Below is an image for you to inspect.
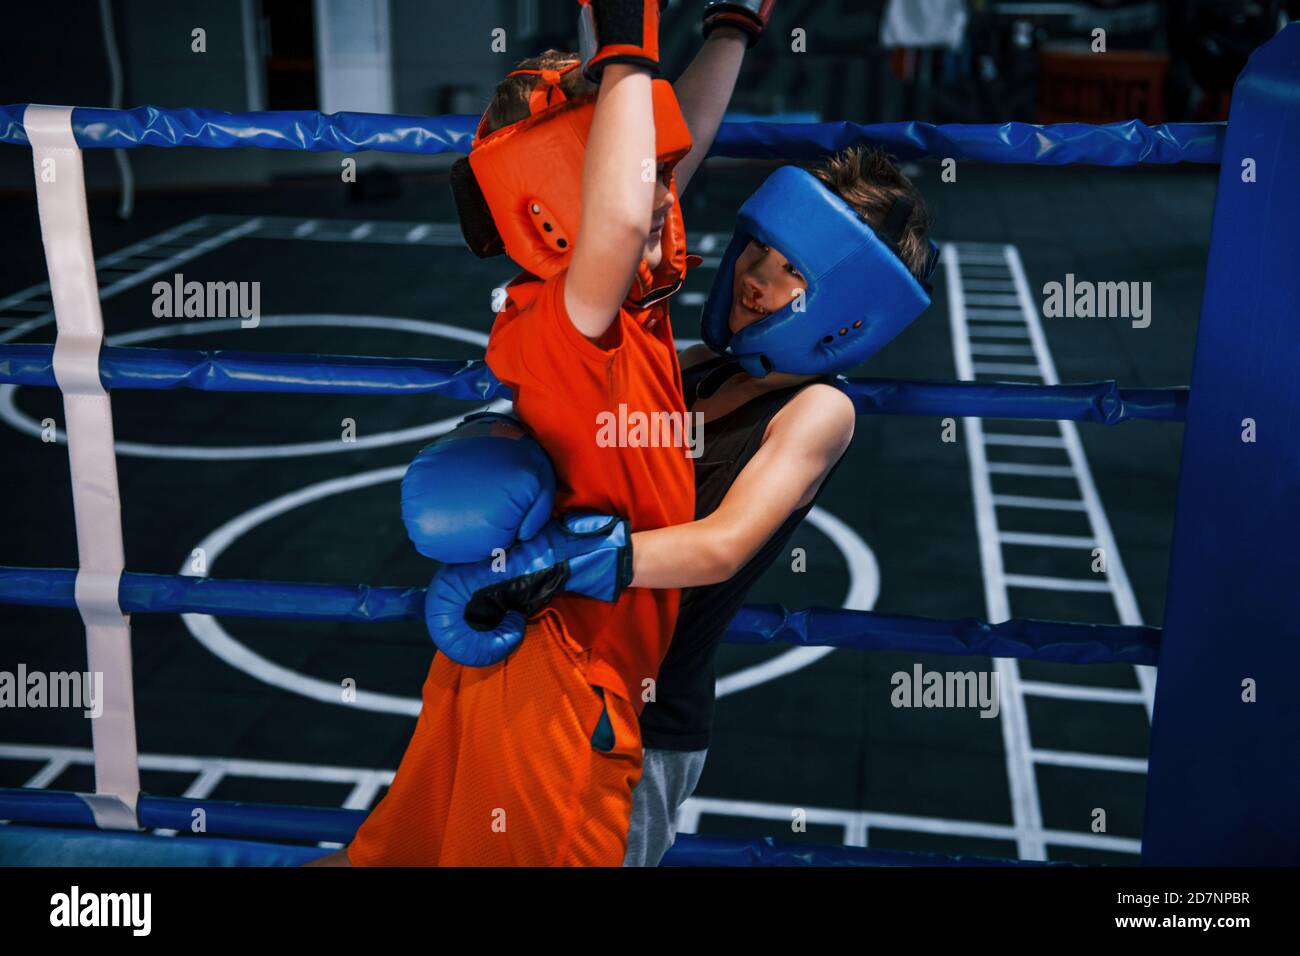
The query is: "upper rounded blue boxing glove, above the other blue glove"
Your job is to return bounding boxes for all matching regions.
[402,412,555,563]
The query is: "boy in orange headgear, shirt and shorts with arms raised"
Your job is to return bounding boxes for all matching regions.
[323,0,771,865]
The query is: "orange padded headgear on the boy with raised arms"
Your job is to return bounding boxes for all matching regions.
[451,60,690,278]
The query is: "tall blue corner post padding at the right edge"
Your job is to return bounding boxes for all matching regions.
[1143,23,1300,866]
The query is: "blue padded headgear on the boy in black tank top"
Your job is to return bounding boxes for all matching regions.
[701,166,939,378]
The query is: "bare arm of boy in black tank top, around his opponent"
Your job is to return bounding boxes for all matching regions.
[632,385,855,588]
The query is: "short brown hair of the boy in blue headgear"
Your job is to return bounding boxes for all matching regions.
[809,146,930,281]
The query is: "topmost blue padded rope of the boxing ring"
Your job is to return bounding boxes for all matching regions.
[0,103,1223,166]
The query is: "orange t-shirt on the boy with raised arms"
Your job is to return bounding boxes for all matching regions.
[488,267,696,713]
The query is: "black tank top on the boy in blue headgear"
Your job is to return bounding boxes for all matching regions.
[641,356,840,750]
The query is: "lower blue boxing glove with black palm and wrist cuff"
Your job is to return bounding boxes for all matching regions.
[424,514,632,667]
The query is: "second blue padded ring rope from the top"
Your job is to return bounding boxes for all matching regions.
[0,345,1187,425]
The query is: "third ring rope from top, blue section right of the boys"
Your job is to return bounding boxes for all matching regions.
[727,605,1160,663]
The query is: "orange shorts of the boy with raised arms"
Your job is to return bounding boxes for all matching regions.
[347,611,641,866]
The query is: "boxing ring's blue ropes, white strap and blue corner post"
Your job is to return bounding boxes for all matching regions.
[0,26,1300,866]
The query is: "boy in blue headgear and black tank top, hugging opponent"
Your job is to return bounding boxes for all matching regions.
[624,148,939,866]
